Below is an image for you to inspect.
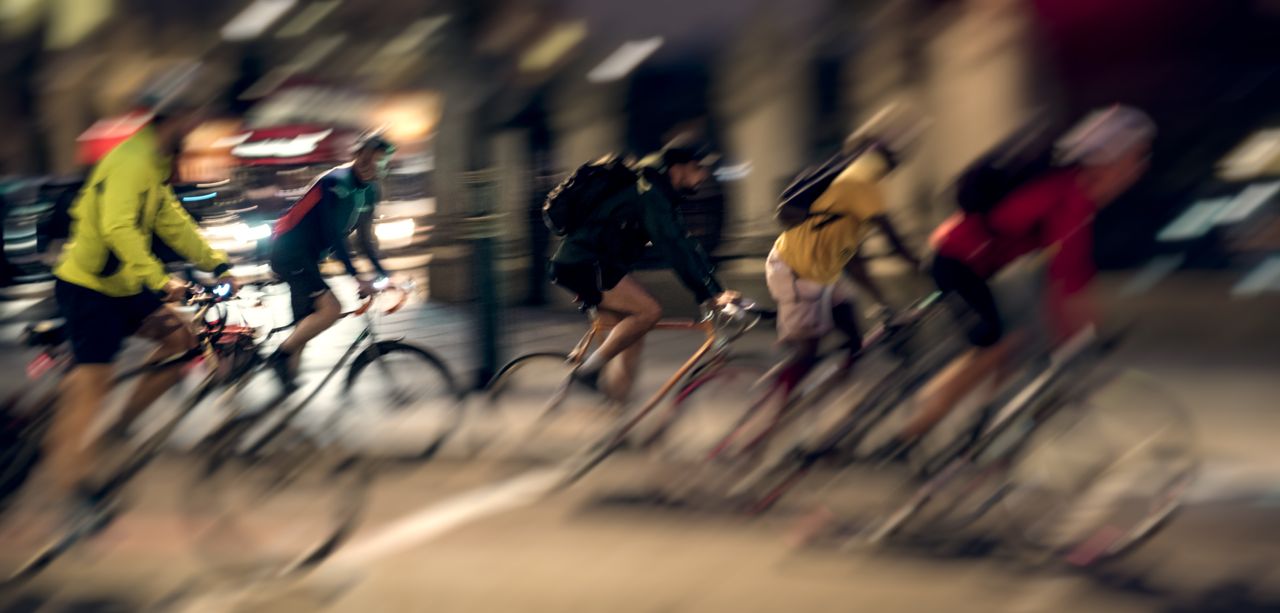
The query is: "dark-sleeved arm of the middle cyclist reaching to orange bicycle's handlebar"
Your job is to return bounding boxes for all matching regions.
[639,186,724,302]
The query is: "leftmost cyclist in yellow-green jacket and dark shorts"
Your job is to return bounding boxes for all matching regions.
[47,76,234,517]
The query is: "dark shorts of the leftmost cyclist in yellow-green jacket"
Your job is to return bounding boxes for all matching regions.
[54,279,182,363]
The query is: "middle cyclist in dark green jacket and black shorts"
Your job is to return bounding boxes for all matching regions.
[549,138,731,399]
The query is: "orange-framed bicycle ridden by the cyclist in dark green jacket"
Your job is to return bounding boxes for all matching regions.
[485,301,771,488]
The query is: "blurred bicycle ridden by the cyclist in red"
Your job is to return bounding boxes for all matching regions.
[847,328,1198,567]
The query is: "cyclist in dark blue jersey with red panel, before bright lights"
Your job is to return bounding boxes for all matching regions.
[269,131,396,388]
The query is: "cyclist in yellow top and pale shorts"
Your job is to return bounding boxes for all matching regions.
[765,107,920,393]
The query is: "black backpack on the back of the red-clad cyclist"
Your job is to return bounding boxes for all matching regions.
[955,119,1057,215]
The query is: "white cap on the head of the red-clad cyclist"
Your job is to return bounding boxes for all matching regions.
[1056,105,1156,166]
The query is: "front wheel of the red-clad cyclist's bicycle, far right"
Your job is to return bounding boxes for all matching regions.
[1001,372,1198,566]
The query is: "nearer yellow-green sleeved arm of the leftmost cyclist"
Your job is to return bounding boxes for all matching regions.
[100,165,180,292]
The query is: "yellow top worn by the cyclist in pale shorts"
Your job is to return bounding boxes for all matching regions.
[773,152,888,285]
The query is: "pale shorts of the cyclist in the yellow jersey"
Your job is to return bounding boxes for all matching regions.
[764,251,854,340]
